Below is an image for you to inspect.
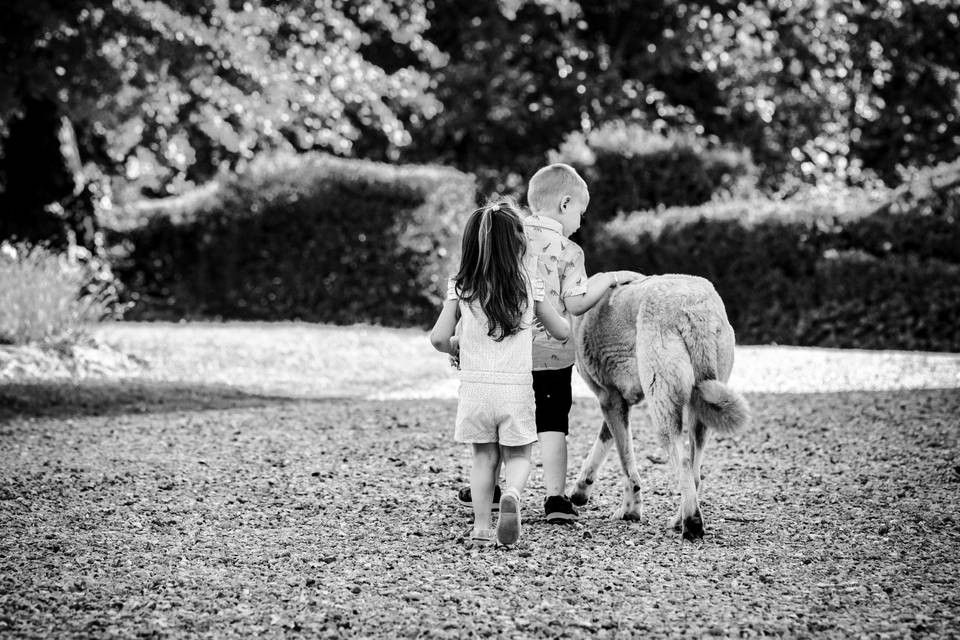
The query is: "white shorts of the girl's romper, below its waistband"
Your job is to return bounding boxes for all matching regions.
[453,382,537,447]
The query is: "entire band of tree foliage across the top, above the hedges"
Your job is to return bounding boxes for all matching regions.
[0,0,960,199]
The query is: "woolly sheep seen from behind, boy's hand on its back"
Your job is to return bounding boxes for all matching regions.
[571,275,750,540]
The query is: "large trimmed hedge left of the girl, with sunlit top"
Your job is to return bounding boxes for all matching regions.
[114,155,476,326]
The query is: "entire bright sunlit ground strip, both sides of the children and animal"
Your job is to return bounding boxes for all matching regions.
[82,322,960,399]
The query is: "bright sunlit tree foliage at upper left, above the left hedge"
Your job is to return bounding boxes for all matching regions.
[0,0,442,195]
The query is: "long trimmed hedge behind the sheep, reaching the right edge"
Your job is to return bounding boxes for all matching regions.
[586,192,960,351]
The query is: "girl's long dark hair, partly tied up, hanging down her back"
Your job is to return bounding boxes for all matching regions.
[456,200,528,342]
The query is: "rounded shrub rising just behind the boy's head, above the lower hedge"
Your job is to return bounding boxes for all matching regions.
[550,122,756,220]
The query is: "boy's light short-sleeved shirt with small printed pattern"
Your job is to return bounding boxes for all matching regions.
[523,215,587,371]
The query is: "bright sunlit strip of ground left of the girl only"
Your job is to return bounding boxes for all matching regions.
[95,322,452,398]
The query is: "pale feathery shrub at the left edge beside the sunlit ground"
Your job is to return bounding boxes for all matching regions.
[0,242,116,344]
